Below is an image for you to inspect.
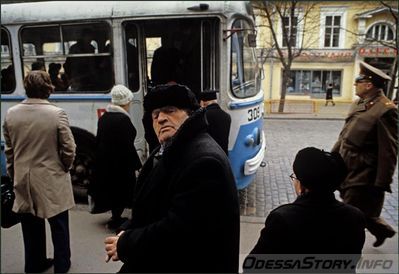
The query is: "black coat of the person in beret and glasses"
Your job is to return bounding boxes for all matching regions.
[243,192,366,273]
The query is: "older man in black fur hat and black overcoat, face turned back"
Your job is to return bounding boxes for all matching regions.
[105,84,240,273]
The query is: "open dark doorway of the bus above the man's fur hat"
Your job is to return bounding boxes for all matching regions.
[124,18,219,156]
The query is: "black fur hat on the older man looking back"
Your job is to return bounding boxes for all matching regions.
[144,84,200,113]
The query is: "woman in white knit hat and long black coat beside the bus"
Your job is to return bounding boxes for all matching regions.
[89,85,141,229]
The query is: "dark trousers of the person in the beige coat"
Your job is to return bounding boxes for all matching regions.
[21,211,71,273]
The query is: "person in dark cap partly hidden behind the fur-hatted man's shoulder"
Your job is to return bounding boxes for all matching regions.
[199,90,231,155]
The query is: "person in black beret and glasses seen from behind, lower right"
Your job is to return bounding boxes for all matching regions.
[243,147,365,273]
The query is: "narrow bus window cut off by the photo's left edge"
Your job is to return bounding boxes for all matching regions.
[1,28,15,94]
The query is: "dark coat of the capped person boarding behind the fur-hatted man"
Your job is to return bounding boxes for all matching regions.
[206,104,231,154]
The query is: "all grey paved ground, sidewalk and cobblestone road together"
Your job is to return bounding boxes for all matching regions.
[0,116,398,273]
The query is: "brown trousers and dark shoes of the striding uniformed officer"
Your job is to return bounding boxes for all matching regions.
[341,186,394,237]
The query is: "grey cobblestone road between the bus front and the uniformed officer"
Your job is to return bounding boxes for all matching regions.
[244,119,398,226]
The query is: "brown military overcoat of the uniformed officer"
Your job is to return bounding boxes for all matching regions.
[332,91,398,192]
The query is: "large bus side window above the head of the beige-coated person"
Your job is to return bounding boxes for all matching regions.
[21,23,114,93]
